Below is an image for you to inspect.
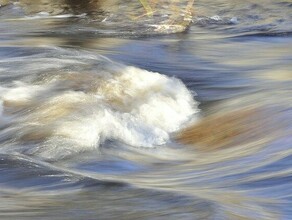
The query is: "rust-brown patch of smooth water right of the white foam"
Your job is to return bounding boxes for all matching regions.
[175,109,266,151]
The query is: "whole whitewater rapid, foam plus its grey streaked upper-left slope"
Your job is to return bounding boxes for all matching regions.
[0,48,198,158]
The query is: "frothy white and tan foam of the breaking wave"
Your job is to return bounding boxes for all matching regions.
[0,51,198,157]
